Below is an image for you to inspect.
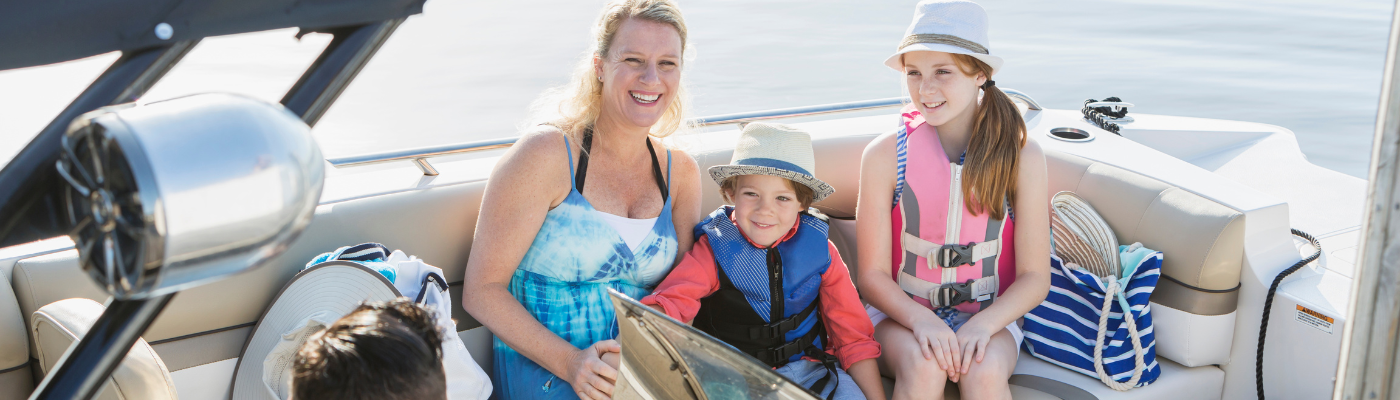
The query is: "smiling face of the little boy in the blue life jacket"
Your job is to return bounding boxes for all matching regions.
[729,175,802,248]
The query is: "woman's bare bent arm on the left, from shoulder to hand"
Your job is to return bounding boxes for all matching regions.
[462,126,616,392]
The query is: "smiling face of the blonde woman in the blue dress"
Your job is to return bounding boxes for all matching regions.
[594,18,680,129]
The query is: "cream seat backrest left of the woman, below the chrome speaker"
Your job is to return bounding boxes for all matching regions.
[9,182,484,379]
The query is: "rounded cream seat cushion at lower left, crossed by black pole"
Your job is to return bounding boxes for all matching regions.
[29,298,178,400]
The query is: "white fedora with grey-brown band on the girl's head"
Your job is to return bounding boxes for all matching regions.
[885,0,1001,78]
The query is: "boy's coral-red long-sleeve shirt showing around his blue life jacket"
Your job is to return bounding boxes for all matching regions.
[641,218,881,368]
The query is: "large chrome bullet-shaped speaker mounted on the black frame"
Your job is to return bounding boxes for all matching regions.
[56,94,325,299]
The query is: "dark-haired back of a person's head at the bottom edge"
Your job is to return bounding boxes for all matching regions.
[293,298,447,400]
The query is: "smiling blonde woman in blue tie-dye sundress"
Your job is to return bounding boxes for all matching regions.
[462,0,700,399]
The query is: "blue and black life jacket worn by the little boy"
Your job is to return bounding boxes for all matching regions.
[693,206,832,368]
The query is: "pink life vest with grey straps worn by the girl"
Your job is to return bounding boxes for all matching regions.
[890,105,1016,313]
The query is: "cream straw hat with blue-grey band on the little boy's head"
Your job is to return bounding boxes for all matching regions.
[710,122,836,203]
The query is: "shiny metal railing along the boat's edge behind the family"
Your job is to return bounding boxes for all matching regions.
[326,88,1043,176]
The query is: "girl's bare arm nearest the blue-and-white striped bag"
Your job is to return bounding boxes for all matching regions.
[959,138,1050,365]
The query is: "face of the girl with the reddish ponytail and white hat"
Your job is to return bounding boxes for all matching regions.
[903,52,987,126]
